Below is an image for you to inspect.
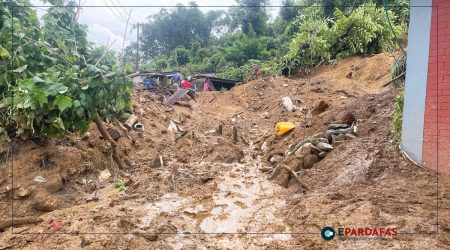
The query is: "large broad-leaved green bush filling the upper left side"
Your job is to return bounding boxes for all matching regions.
[0,0,132,139]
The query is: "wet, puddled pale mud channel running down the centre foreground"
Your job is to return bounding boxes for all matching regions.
[135,152,291,249]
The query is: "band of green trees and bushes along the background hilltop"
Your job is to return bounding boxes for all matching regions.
[126,0,409,80]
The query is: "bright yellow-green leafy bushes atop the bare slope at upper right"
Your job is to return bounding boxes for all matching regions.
[284,4,406,69]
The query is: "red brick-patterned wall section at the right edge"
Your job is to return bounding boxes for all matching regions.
[422,0,450,173]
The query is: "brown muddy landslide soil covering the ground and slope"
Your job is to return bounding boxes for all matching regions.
[0,53,450,249]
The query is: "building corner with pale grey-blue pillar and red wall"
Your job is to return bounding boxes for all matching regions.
[401,0,450,173]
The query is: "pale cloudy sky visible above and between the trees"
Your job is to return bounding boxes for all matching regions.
[31,0,281,51]
